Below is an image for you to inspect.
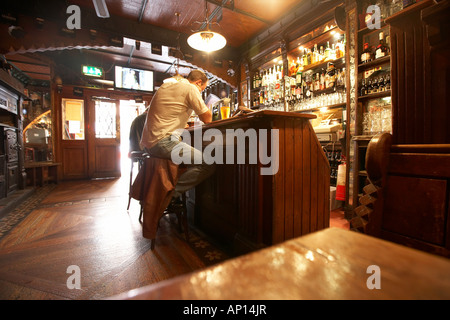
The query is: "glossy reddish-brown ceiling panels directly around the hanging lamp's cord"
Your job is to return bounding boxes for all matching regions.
[71,0,301,48]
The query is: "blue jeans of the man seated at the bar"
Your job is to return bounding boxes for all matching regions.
[147,136,215,197]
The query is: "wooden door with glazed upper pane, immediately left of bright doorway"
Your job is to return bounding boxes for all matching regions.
[88,100,120,178]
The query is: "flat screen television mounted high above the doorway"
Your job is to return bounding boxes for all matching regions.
[114,66,153,92]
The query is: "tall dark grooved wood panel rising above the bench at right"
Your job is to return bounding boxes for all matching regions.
[386,0,450,144]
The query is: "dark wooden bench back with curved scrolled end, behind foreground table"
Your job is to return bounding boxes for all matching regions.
[366,134,450,257]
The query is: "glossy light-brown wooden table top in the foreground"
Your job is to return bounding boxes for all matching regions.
[112,228,450,300]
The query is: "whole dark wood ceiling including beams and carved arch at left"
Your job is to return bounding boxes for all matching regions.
[0,0,338,88]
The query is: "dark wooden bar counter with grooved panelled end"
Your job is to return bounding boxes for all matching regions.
[187,110,330,254]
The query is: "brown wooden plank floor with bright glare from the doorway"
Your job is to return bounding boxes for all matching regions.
[0,178,345,300]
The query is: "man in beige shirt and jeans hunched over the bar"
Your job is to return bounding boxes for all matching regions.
[141,70,214,203]
